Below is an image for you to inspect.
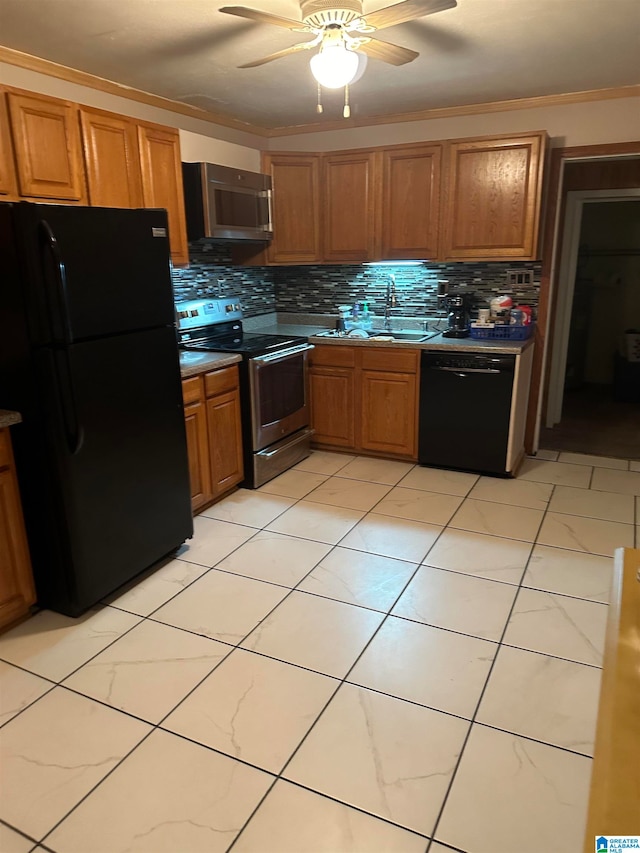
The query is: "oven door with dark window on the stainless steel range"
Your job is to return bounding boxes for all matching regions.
[249,344,313,452]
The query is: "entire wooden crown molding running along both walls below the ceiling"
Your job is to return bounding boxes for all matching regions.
[0,45,640,138]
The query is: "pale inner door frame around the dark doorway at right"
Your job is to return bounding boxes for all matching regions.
[545,189,640,428]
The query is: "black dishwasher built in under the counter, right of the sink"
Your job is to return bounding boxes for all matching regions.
[418,351,516,477]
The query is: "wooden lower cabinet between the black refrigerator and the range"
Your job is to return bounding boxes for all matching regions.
[182,365,244,512]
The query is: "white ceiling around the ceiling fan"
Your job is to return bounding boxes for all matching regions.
[0,0,640,128]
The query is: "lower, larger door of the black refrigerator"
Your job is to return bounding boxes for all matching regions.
[24,327,193,616]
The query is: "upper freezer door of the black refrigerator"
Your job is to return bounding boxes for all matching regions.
[15,202,175,345]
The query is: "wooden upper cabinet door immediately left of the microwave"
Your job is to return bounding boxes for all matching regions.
[138,124,189,265]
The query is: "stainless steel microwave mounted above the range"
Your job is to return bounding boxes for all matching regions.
[182,163,273,241]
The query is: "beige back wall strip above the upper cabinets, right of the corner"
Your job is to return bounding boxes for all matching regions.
[269,97,640,151]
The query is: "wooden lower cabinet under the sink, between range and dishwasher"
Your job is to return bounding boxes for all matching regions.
[309,345,419,460]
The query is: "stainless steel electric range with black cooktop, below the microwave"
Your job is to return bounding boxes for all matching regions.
[176,297,313,489]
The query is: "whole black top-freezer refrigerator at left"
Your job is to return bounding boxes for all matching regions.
[0,202,193,616]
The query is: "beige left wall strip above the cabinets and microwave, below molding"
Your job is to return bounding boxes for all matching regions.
[0,62,265,170]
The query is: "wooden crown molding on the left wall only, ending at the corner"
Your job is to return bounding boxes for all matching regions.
[0,45,267,136]
